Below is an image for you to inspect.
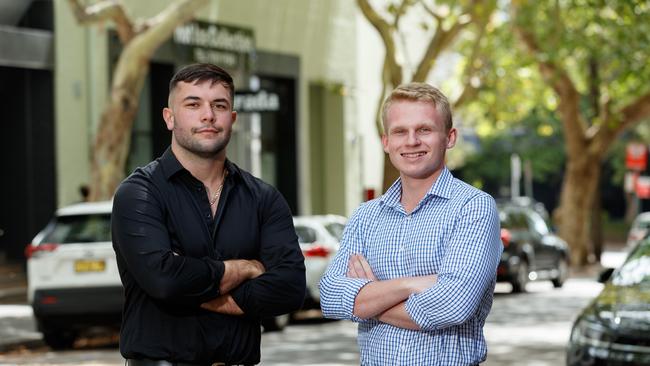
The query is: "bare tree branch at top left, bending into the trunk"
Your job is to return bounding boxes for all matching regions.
[68,0,135,44]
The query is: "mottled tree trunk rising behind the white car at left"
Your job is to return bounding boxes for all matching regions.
[89,58,149,201]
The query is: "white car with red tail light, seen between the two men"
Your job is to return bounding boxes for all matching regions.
[293,215,347,309]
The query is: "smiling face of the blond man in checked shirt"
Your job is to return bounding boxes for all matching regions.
[381,100,456,180]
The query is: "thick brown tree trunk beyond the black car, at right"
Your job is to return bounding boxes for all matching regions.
[555,152,601,266]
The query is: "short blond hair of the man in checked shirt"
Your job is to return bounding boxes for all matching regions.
[381,83,453,133]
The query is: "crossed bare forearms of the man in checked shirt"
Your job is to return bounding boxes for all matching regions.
[347,254,437,330]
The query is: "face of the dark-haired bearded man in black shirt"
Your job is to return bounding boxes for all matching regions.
[163,81,237,158]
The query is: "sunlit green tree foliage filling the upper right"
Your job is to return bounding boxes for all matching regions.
[458,0,650,192]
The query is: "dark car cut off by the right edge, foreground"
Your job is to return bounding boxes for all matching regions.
[567,237,650,366]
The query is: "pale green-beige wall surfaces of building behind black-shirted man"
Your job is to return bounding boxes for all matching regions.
[54,0,361,214]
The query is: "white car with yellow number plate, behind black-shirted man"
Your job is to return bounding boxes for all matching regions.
[25,201,119,349]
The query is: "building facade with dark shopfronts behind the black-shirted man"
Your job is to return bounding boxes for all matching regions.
[0,0,388,264]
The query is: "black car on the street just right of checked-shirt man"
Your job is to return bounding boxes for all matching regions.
[497,202,569,293]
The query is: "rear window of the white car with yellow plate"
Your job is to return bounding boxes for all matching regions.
[43,214,111,244]
